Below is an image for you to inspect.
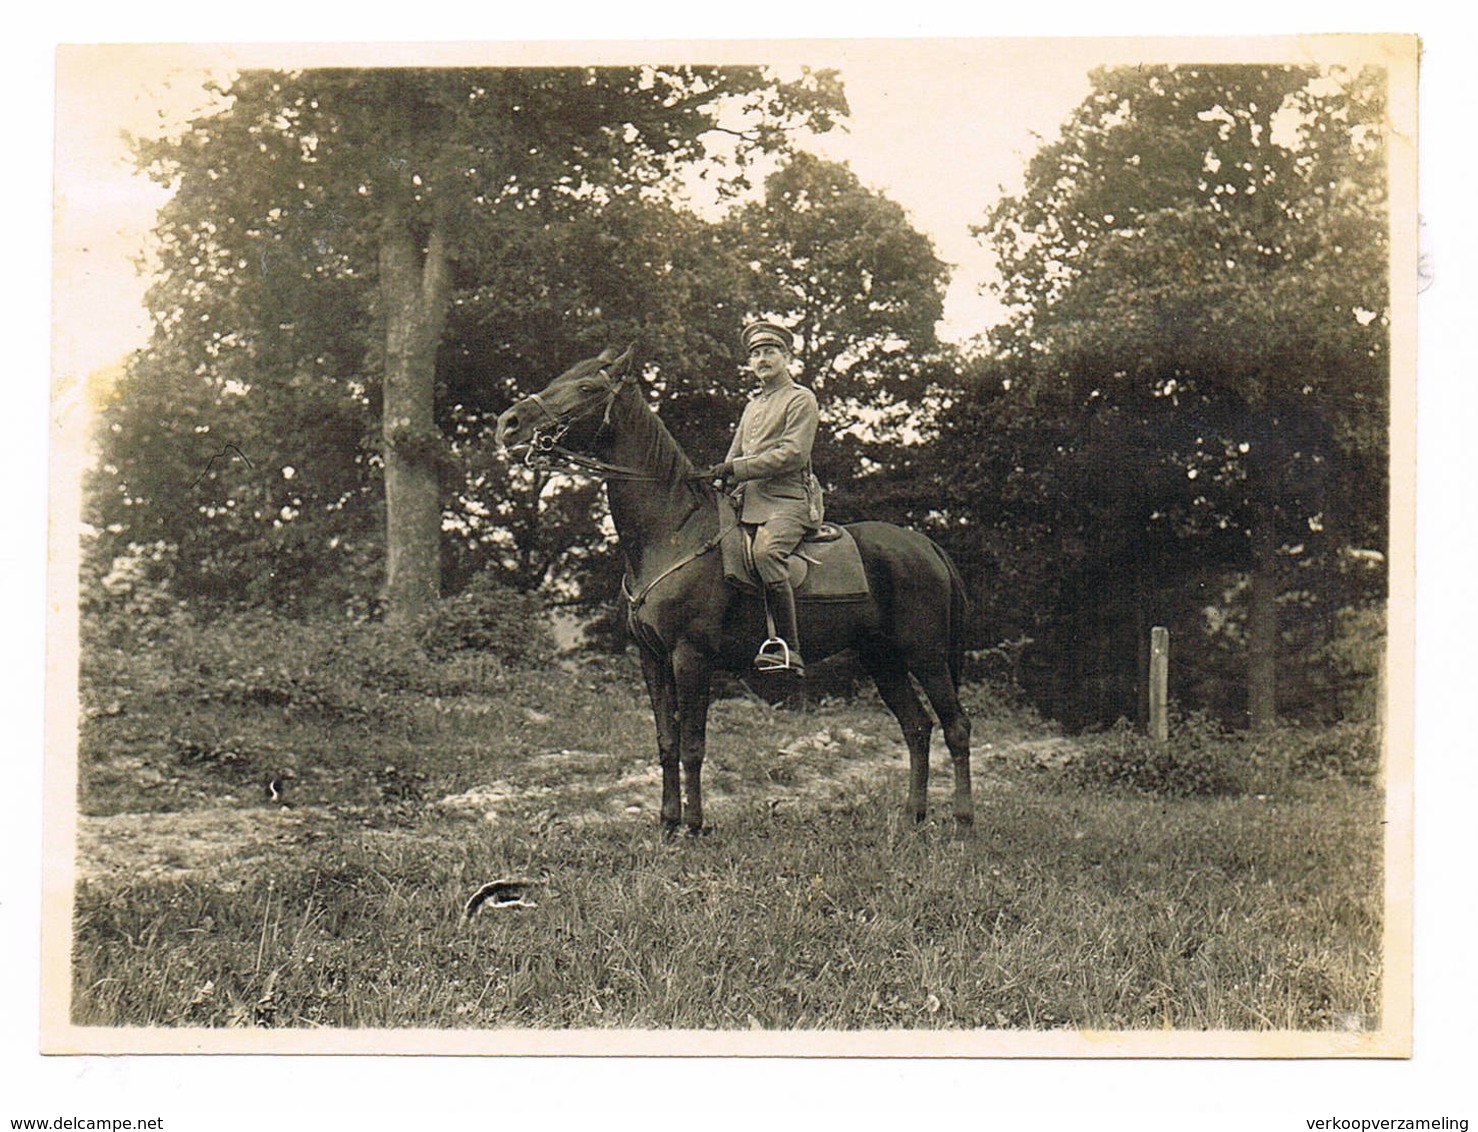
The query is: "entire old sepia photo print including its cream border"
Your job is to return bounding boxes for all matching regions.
[41,35,1422,1058]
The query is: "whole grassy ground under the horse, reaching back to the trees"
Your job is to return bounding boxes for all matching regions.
[72,638,1382,1030]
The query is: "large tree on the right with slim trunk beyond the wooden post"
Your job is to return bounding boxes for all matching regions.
[980,67,1389,727]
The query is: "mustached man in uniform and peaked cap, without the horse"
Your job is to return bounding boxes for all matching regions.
[708,322,823,677]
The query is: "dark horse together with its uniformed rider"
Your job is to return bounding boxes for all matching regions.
[497,345,974,833]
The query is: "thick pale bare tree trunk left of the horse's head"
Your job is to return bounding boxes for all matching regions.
[380,210,448,624]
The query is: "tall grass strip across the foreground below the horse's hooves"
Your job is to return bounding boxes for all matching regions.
[75,788,1380,1030]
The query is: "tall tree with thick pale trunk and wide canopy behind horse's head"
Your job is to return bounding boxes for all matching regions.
[111,67,845,619]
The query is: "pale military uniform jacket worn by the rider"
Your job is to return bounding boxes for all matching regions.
[724,381,822,526]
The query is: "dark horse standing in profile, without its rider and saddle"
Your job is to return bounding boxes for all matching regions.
[498,349,974,833]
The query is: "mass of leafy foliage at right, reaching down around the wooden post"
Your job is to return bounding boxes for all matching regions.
[958,67,1389,723]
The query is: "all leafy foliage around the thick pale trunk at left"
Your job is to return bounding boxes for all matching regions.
[90,67,845,612]
